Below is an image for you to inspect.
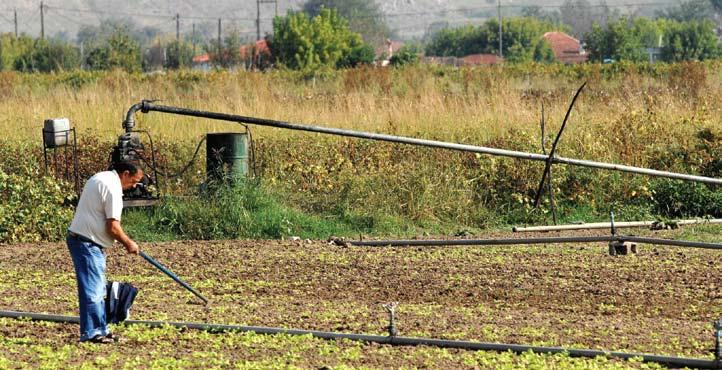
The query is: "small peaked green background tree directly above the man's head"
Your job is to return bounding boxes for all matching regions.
[86,27,141,72]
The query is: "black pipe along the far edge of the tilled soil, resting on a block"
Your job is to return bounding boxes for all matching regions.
[347,235,722,249]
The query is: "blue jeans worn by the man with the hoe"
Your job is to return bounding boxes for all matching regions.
[66,237,110,342]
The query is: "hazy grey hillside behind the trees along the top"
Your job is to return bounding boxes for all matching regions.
[0,0,679,40]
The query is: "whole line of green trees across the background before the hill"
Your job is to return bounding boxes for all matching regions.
[0,5,722,72]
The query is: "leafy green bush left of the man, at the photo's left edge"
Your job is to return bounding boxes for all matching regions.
[0,167,75,243]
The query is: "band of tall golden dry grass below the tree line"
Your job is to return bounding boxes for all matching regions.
[0,63,722,154]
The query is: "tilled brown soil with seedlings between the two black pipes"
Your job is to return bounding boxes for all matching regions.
[0,234,722,367]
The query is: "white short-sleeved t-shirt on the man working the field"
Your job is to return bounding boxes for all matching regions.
[68,171,123,248]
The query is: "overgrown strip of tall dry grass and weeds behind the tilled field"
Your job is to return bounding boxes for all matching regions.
[0,62,722,237]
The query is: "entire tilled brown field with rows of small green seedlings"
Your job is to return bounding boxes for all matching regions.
[0,226,722,368]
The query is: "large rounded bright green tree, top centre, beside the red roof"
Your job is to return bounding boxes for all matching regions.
[269,8,372,70]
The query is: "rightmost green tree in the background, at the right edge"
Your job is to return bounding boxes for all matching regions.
[662,21,720,62]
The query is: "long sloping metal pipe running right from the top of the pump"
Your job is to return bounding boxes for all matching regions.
[123,101,722,185]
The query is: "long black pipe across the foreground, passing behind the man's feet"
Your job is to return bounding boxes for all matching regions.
[0,311,718,369]
